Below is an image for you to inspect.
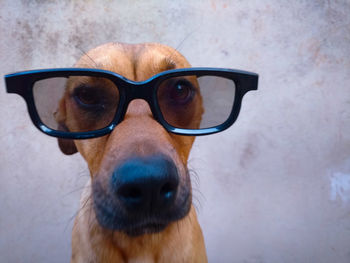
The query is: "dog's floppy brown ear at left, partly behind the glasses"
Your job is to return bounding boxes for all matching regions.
[55,97,78,155]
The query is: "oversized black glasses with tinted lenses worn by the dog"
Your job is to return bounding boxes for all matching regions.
[5,68,258,139]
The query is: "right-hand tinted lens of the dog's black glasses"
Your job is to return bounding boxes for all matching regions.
[157,75,236,129]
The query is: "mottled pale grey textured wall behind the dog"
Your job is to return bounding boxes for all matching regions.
[0,0,350,263]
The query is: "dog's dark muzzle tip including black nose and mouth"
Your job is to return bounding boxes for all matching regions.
[93,155,191,236]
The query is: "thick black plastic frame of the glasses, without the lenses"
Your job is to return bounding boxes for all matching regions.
[5,68,258,139]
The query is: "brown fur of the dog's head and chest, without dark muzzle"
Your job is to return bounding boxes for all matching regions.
[57,43,207,263]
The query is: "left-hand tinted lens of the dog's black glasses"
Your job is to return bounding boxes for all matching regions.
[33,76,119,132]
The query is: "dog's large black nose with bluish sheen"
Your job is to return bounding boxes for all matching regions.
[111,155,179,214]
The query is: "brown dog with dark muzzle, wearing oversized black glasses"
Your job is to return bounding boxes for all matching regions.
[56,43,207,263]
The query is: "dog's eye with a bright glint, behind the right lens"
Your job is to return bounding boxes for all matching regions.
[168,79,195,104]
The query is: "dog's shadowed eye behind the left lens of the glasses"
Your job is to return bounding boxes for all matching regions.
[73,86,103,108]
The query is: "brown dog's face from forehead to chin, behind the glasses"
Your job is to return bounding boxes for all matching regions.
[56,44,203,236]
